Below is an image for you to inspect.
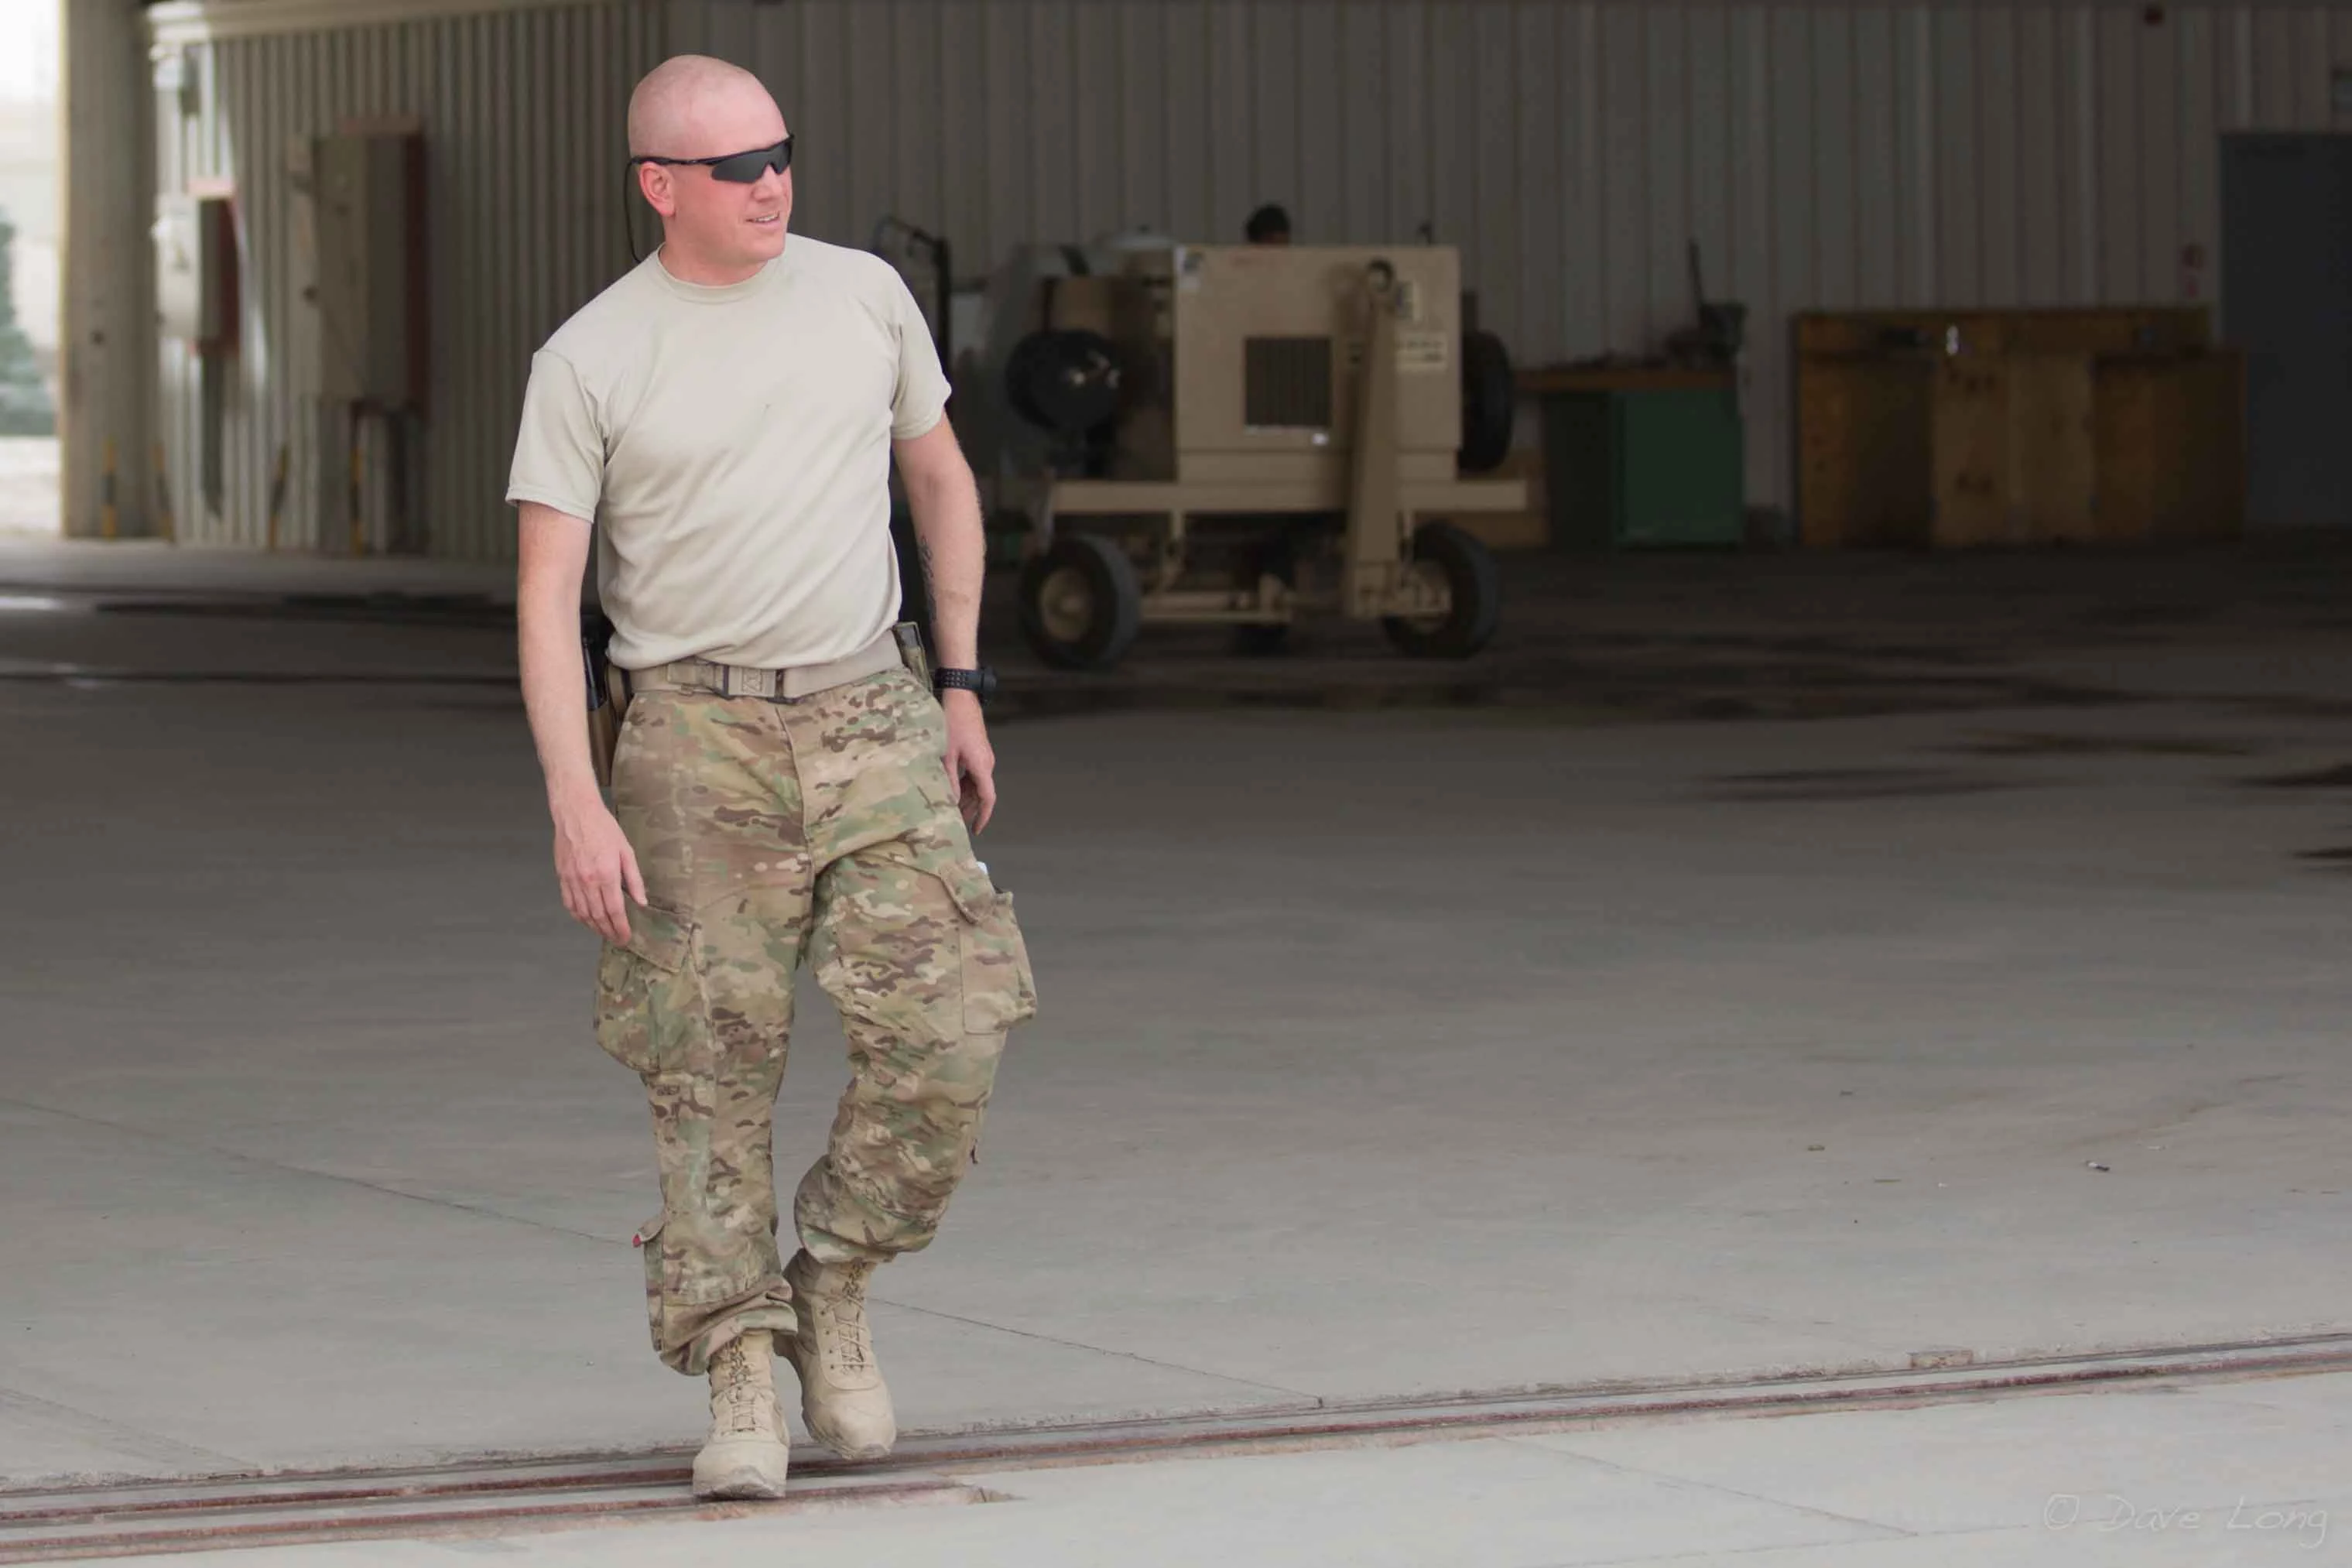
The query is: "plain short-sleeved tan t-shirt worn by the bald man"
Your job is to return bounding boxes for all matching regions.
[505,235,948,670]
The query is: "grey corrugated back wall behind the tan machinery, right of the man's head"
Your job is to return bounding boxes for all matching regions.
[673,0,2352,526]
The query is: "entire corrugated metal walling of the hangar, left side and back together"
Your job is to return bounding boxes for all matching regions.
[152,0,2352,555]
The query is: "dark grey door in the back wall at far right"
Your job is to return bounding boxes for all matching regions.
[2220,136,2352,529]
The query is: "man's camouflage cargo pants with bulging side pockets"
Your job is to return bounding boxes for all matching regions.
[597,670,1037,1375]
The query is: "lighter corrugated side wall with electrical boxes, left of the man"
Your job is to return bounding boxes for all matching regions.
[158,5,663,560]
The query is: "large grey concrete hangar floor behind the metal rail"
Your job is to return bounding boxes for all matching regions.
[0,533,2352,1514]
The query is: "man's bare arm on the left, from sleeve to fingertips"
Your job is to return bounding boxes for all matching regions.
[515,501,645,943]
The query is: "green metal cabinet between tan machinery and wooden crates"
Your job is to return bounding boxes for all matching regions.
[1543,388,1748,550]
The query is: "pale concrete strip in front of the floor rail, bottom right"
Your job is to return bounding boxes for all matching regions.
[83,1375,2352,1568]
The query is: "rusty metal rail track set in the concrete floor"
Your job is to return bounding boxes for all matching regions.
[0,1335,2352,1563]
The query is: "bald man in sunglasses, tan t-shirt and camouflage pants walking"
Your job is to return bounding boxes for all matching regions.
[508,56,1037,1498]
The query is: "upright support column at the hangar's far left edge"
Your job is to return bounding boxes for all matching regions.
[59,0,156,539]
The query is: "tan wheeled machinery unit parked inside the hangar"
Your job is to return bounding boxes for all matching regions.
[974,242,1526,668]
